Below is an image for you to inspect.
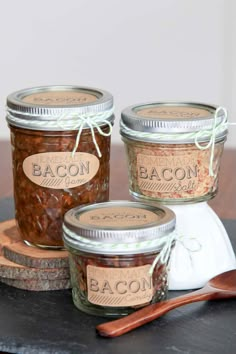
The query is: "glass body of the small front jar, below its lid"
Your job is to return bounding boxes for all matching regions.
[69,249,168,317]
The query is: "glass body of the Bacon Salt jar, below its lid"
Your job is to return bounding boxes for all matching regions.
[123,138,224,203]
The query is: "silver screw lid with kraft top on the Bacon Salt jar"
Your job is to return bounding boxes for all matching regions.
[120,102,227,144]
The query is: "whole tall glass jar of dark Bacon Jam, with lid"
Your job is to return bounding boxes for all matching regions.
[7,86,114,248]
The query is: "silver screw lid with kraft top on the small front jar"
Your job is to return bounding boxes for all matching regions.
[63,201,175,254]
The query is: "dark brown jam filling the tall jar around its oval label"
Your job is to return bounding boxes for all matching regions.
[11,126,110,247]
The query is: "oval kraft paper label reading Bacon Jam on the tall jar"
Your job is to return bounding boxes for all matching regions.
[23,152,100,189]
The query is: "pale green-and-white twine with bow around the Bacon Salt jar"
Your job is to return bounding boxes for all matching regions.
[121,107,236,177]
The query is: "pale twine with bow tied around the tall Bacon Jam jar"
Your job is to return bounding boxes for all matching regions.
[8,108,114,157]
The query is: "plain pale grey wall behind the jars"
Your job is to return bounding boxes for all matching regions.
[0,0,236,147]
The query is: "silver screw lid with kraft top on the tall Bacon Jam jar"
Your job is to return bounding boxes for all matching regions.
[6,85,114,131]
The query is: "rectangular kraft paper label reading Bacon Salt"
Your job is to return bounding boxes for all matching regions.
[137,153,199,193]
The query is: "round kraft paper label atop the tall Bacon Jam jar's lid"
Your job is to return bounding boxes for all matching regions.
[22,91,98,106]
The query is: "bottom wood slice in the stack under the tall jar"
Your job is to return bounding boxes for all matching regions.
[0,278,71,291]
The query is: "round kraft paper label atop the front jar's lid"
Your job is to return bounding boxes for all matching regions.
[77,207,160,228]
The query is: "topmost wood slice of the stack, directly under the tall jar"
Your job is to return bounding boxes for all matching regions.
[0,220,69,269]
